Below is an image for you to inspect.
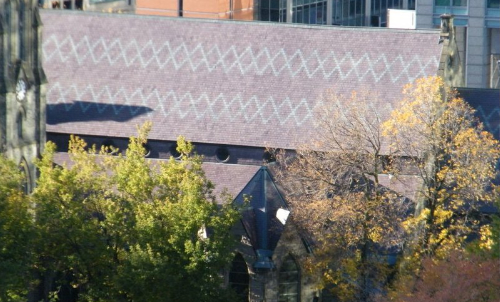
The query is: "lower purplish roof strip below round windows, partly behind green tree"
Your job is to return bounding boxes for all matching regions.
[54,152,260,201]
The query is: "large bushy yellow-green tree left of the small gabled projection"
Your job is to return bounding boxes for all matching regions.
[33,124,239,301]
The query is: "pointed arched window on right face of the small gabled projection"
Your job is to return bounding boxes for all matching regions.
[278,255,300,302]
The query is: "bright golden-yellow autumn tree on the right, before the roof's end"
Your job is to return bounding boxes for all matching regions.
[384,77,500,264]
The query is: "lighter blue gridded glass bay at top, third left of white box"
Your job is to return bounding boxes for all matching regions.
[292,0,327,24]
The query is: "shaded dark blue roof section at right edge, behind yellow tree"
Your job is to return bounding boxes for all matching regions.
[457,88,500,139]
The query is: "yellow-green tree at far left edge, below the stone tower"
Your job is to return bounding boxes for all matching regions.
[0,154,34,301]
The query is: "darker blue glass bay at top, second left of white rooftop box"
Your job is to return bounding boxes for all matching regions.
[332,0,366,26]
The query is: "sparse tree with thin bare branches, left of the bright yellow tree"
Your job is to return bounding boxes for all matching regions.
[274,93,408,301]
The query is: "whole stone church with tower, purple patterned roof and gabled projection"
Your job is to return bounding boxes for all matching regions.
[0,0,498,302]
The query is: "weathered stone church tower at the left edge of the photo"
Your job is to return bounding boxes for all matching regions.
[0,0,46,191]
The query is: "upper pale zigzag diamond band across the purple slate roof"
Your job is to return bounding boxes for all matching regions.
[43,34,439,83]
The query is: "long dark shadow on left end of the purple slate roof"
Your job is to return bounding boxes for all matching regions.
[47,101,153,125]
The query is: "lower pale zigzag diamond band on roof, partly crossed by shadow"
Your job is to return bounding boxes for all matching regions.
[47,82,319,126]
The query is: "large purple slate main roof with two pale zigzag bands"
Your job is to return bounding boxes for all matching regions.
[41,10,442,149]
